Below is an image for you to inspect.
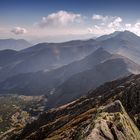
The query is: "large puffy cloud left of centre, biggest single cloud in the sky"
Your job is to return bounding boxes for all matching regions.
[38,11,82,27]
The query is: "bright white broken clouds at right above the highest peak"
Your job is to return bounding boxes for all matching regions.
[87,15,140,36]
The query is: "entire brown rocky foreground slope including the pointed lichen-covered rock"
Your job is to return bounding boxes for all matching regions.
[8,75,140,140]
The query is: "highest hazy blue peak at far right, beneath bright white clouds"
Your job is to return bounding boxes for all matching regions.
[96,31,140,64]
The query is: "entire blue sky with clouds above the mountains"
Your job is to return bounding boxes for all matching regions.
[0,0,140,43]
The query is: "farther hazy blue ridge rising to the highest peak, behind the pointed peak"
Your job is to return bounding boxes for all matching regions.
[0,31,140,81]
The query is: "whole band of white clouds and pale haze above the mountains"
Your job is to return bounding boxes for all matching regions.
[3,11,140,42]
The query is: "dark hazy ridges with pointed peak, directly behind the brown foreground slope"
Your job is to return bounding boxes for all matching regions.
[0,48,140,108]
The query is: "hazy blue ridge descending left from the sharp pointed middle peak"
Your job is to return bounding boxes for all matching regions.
[0,48,112,94]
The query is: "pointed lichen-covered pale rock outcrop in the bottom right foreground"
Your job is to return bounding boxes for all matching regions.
[86,101,140,140]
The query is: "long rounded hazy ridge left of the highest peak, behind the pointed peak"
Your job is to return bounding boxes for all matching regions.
[0,40,97,81]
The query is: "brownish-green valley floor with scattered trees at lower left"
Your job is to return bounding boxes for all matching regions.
[0,95,47,139]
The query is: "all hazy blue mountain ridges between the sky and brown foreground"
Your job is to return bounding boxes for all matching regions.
[0,31,140,107]
